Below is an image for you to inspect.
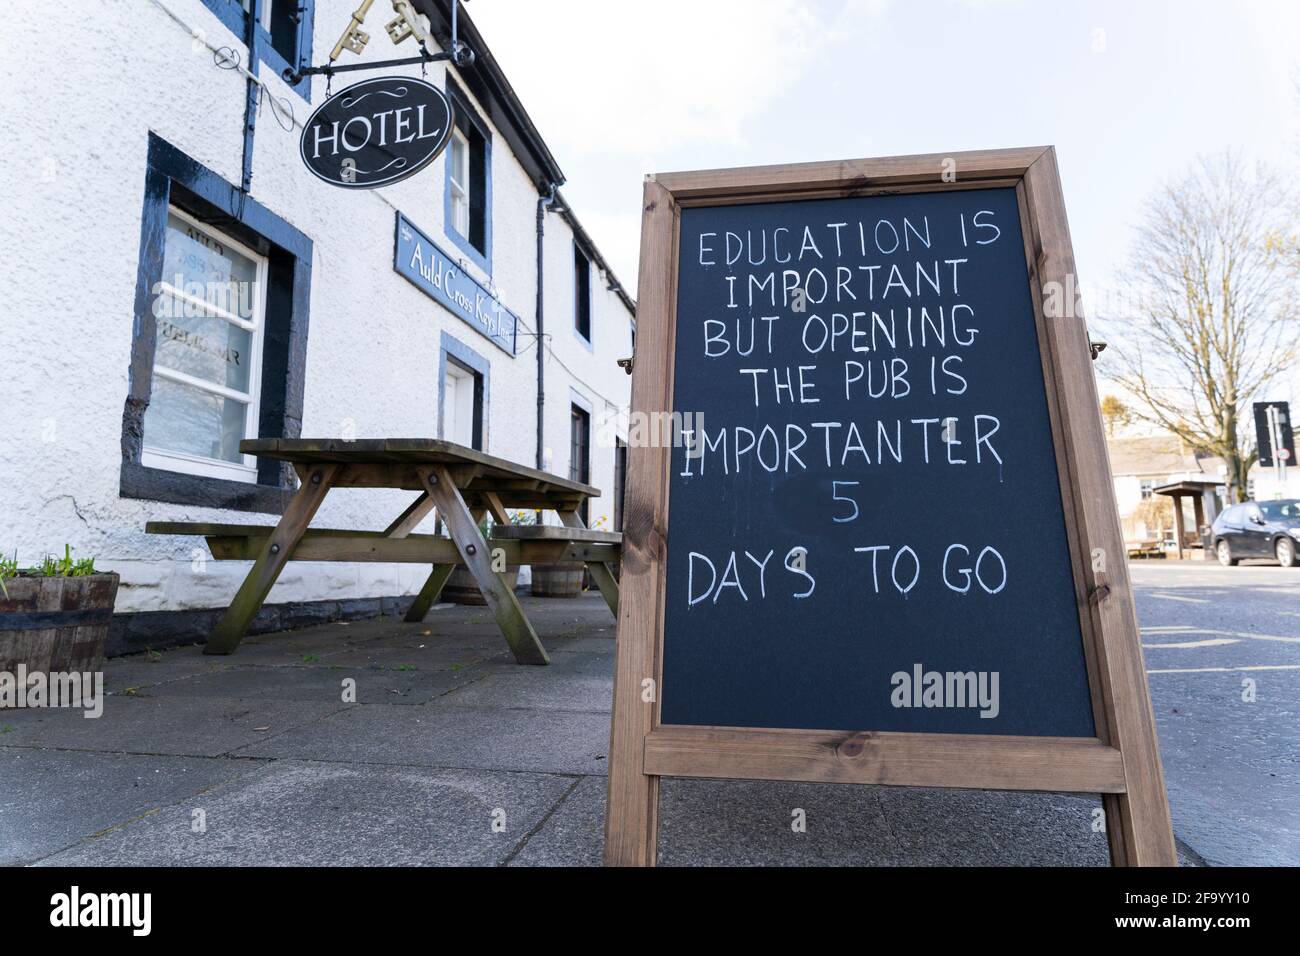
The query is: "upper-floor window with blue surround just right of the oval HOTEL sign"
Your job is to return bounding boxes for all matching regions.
[443,77,491,274]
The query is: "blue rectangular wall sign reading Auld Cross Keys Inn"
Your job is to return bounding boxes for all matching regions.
[393,212,519,355]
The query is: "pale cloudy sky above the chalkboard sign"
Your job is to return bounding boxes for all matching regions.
[465,0,1300,314]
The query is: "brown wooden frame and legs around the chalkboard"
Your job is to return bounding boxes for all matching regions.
[605,147,1177,866]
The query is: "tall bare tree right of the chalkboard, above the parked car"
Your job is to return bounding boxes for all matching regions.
[1104,155,1300,501]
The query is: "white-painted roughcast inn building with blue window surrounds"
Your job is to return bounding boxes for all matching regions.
[0,0,634,650]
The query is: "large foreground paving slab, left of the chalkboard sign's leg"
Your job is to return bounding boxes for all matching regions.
[40,761,575,866]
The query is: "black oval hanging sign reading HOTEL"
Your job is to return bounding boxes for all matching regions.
[298,77,455,189]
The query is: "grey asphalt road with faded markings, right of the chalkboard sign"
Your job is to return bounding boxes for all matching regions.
[1130,561,1300,866]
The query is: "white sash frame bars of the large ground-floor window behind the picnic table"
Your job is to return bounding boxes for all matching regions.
[140,206,268,484]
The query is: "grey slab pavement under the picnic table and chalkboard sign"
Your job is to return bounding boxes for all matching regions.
[0,584,1242,865]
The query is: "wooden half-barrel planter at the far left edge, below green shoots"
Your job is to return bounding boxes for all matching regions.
[0,572,118,674]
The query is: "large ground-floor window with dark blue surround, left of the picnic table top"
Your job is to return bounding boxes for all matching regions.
[121,134,312,514]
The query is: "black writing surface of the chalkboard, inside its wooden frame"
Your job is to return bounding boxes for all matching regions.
[660,189,1095,737]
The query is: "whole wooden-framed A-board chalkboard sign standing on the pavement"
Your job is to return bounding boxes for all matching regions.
[606,148,1175,865]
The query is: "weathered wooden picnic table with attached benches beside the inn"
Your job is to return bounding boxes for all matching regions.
[146,438,623,663]
